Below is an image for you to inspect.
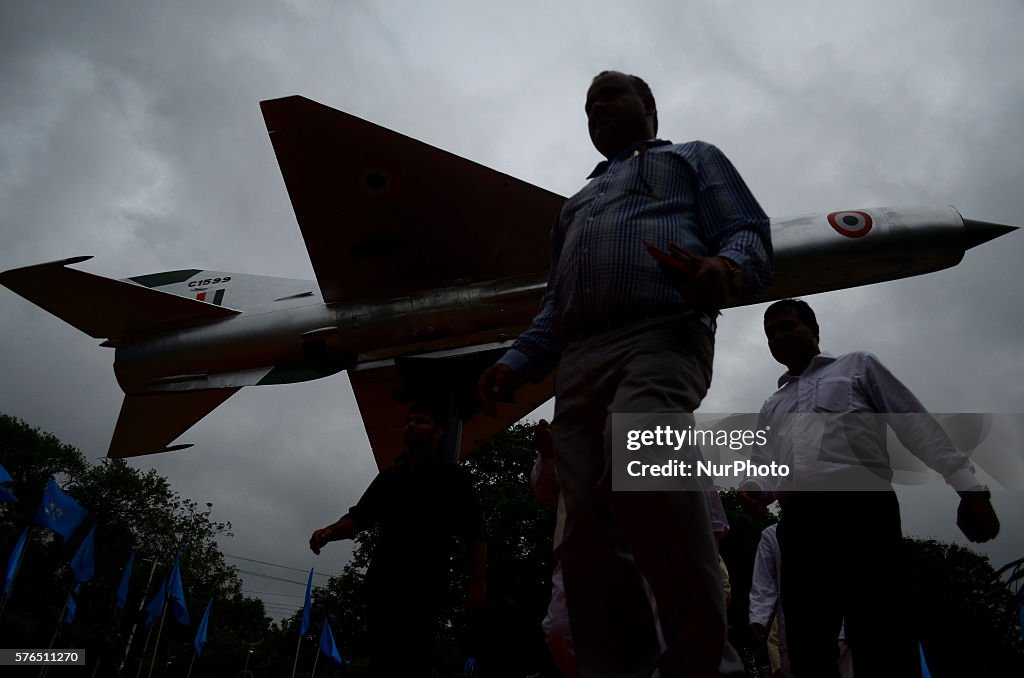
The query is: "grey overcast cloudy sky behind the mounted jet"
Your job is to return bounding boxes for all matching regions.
[0,0,1024,617]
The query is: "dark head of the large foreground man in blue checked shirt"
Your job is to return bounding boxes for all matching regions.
[584,71,657,160]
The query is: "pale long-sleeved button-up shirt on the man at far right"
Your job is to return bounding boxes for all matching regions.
[743,351,979,497]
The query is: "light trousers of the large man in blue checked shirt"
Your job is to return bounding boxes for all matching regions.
[552,316,745,678]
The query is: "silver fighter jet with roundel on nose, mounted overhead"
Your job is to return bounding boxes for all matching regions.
[0,96,1014,468]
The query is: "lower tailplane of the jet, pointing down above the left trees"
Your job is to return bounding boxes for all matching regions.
[106,387,241,459]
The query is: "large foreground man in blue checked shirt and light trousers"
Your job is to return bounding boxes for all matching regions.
[479,72,771,678]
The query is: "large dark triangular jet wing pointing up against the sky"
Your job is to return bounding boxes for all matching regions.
[260,96,564,303]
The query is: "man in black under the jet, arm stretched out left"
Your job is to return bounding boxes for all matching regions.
[309,404,486,678]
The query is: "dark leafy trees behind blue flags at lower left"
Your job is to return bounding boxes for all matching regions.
[0,415,269,675]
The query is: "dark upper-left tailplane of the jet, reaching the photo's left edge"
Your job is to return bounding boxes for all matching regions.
[0,257,239,341]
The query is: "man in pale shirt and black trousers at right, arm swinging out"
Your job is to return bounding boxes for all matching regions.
[740,299,999,678]
